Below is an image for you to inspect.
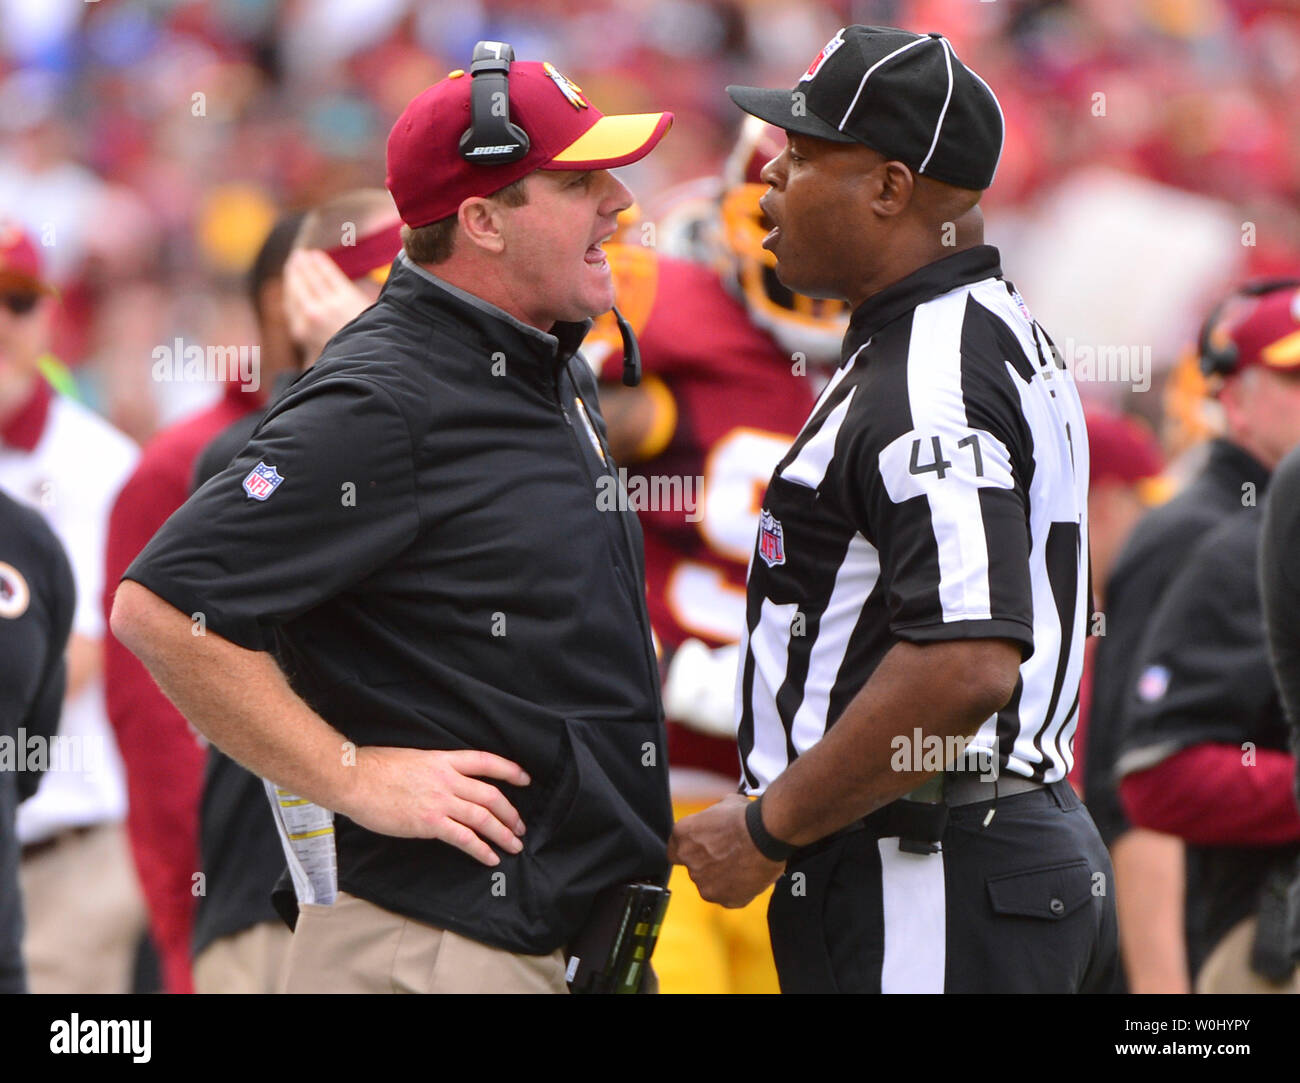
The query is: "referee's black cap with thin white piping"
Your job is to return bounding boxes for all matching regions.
[727,26,1004,191]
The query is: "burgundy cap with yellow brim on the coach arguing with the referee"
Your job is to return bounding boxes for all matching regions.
[387,60,672,229]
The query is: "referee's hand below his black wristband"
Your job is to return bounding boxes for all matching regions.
[668,793,785,907]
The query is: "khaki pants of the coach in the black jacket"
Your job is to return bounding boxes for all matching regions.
[283,892,568,993]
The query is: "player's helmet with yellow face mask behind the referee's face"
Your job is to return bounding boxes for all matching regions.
[718,117,849,364]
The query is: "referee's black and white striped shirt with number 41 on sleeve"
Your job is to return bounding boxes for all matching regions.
[737,246,1089,793]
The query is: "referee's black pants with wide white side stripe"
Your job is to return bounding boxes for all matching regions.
[767,783,1119,993]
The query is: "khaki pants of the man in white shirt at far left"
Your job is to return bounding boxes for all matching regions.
[20,823,146,993]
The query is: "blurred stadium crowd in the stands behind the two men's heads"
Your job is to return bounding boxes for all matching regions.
[0,0,1300,441]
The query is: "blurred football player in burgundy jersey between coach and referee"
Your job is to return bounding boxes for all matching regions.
[584,118,848,993]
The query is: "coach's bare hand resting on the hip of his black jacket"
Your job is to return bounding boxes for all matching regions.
[339,748,530,866]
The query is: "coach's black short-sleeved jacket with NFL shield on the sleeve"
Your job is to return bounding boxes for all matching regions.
[126,249,672,953]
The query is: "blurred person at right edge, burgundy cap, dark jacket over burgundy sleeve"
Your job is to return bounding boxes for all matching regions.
[1115,282,1300,993]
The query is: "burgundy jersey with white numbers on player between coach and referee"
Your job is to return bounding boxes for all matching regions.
[586,244,814,776]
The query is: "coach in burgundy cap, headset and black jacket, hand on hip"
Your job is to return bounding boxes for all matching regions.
[113,43,672,992]
